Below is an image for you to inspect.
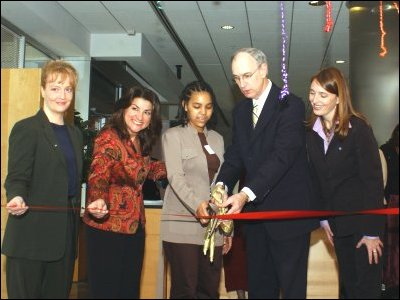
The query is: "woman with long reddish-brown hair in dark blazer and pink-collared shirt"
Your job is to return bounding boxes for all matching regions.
[307,68,384,299]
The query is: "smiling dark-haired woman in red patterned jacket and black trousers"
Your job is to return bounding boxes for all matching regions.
[83,87,166,299]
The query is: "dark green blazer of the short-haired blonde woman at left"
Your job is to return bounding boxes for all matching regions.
[2,110,83,261]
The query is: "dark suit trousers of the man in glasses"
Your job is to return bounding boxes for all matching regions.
[245,223,310,299]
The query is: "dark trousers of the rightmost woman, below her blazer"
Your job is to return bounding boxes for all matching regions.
[334,235,382,299]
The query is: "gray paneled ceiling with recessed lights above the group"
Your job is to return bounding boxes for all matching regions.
[1,1,349,135]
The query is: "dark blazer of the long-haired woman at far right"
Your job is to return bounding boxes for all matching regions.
[307,117,384,238]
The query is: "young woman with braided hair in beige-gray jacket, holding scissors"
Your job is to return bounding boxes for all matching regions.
[161,81,231,299]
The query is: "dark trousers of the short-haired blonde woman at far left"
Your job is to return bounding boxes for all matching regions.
[6,213,77,299]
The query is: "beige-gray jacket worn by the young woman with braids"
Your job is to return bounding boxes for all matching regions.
[161,126,224,246]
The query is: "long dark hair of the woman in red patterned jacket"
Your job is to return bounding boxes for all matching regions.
[102,86,162,156]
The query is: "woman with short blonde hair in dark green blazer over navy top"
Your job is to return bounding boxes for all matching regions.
[2,61,83,298]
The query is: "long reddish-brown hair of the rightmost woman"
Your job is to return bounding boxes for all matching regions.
[306,67,368,138]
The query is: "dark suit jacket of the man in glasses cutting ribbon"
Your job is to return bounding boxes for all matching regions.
[217,84,318,239]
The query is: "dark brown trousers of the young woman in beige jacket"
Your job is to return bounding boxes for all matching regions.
[163,241,222,299]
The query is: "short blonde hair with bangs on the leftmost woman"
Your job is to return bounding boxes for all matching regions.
[40,60,78,92]
